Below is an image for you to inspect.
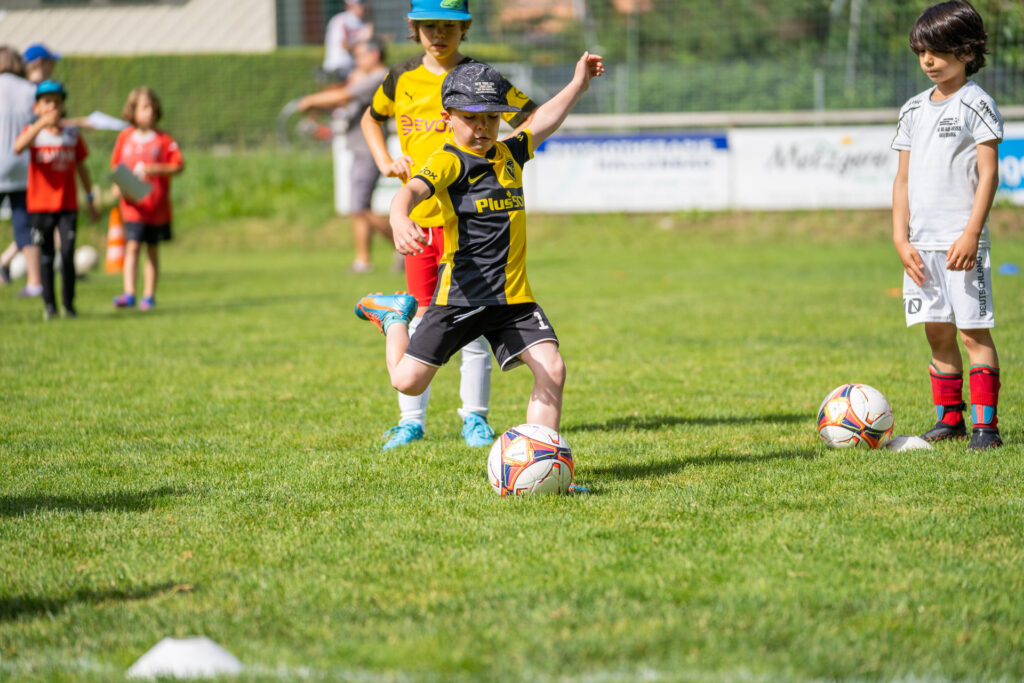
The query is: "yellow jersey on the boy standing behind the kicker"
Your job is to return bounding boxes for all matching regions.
[370,54,537,227]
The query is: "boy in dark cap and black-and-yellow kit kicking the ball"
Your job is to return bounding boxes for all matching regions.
[355,52,604,438]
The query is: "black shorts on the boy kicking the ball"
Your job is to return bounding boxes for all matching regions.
[406,303,558,370]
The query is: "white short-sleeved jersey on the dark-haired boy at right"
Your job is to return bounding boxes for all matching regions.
[892,81,1002,251]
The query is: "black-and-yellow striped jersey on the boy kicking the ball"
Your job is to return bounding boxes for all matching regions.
[416,130,534,306]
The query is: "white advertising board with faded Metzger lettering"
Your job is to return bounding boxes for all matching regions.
[729,123,899,209]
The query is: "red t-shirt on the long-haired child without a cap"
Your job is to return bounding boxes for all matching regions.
[111,126,182,225]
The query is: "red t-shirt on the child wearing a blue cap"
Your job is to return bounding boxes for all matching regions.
[23,126,89,213]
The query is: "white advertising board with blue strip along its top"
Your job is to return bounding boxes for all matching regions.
[523,132,729,213]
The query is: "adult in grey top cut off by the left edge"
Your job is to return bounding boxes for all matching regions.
[0,45,43,297]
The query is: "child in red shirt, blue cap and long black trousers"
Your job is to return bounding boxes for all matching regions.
[14,80,99,319]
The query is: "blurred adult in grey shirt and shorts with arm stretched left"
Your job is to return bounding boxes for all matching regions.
[299,38,393,272]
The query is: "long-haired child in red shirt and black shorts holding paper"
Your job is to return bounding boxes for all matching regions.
[111,87,185,310]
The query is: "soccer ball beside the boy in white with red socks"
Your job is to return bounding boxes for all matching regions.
[818,384,895,449]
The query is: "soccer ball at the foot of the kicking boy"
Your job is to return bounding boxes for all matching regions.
[487,424,573,497]
